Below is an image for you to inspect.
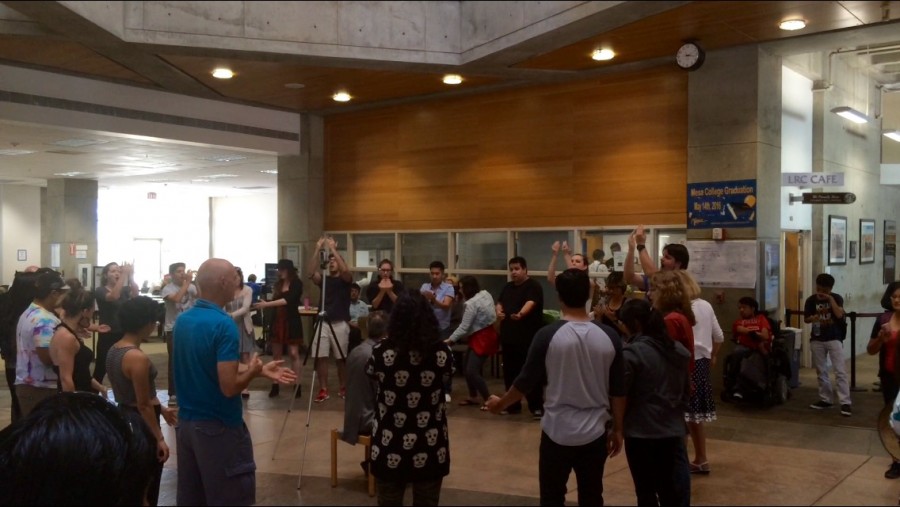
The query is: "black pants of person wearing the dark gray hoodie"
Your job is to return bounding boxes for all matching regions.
[625,437,691,506]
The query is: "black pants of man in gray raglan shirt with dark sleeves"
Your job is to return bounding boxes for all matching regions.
[538,432,606,506]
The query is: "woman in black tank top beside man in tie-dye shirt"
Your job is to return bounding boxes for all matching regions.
[50,285,106,397]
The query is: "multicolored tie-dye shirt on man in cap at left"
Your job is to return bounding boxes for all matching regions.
[16,303,59,389]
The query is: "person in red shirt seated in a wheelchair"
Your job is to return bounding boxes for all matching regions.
[725,297,773,400]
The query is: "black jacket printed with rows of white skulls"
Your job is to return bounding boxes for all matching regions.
[366,338,453,482]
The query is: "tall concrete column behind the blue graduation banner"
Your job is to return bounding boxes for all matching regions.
[687,46,781,386]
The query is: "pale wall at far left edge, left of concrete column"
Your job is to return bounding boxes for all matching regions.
[0,185,41,285]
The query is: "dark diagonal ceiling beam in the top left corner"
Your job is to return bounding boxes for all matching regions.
[3,1,222,100]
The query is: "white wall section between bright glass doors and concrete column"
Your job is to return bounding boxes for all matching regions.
[211,194,274,280]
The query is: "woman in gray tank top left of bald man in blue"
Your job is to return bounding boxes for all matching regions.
[106,296,177,505]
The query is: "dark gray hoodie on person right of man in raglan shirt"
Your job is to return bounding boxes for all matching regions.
[623,336,691,438]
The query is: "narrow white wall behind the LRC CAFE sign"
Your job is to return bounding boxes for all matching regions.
[781,67,813,231]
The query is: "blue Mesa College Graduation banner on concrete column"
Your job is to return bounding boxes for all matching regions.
[687,180,756,229]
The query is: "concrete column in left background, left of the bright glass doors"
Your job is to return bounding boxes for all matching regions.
[40,178,98,283]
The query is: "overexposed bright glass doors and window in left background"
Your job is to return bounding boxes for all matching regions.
[97,188,210,285]
